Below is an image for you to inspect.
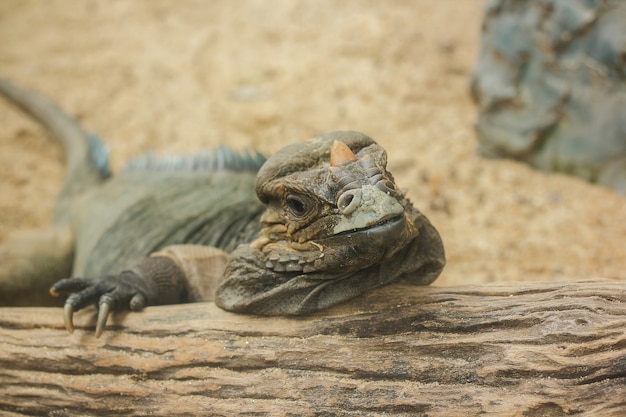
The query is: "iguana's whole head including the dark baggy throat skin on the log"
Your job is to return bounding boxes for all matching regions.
[216,131,445,315]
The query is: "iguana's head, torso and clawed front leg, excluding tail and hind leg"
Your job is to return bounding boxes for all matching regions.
[0,77,445,335]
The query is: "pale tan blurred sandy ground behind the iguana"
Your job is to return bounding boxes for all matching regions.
[0,0,626,285]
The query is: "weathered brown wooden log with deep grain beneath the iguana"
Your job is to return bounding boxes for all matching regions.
[0,281,626,416]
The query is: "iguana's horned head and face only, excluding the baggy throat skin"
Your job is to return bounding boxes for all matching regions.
[249,132,415,276]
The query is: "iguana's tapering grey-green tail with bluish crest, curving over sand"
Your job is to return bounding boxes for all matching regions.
[0,77,110,219]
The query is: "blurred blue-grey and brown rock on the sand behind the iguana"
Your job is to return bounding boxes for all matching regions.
[471,0,626,194]
